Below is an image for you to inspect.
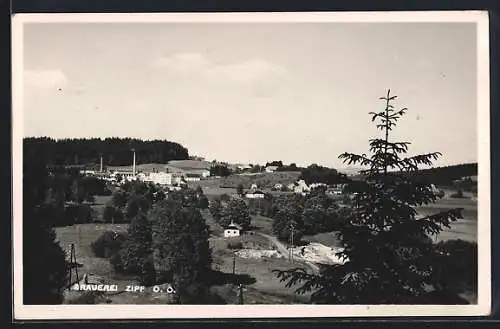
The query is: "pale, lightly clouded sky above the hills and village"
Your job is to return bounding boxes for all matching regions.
[23,22,477,168]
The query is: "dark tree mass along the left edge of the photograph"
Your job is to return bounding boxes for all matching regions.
[23,162,67,305]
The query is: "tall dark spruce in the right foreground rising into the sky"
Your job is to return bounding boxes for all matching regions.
[276,91,461,304]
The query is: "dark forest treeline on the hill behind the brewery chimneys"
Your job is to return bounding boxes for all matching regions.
[24,137,189,166]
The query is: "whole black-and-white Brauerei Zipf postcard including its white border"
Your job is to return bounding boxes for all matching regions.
[12,12,491,319]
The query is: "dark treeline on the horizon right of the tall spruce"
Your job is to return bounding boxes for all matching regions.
[402,163,477,186]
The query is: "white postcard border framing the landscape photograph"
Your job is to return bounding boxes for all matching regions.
[12,11,491,320]
